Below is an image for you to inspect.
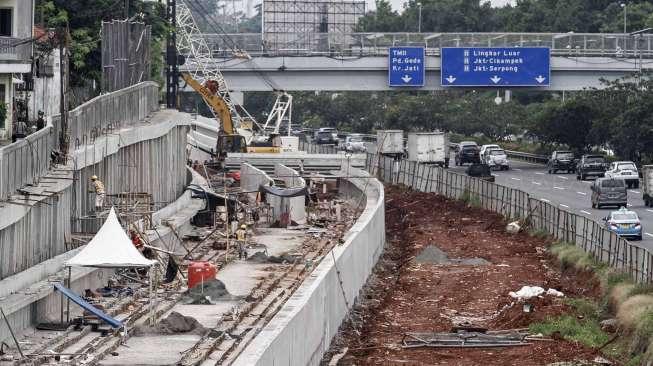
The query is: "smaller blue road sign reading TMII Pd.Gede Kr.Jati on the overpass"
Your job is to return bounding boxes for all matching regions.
[388,47,425,87]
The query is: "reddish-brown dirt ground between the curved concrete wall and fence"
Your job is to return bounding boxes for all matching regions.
[331,187,598,365]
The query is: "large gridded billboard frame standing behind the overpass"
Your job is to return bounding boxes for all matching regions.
[263,0,365,52]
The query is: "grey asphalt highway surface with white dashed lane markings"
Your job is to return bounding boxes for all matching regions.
[450,156,653,251]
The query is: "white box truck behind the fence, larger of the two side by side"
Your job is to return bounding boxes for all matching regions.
[406,131,449,168]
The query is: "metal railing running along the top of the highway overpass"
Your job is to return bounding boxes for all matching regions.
[204,33,653,58]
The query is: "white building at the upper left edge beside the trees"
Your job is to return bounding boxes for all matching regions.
[0,0,34,140]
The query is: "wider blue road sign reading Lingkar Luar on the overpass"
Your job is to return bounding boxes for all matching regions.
[440,47,551,87]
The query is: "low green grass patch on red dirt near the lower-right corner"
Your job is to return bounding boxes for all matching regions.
[528,315,609,348]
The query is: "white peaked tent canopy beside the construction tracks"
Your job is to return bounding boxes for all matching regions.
[66,207,156,268]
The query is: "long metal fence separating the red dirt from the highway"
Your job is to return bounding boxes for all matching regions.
[366,154,653,283]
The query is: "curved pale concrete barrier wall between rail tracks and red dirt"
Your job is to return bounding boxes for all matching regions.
[234,169,385,366]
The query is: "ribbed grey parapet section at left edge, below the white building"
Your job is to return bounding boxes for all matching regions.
[0,126,56,200]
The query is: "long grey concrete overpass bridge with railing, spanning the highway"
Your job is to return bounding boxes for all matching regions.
[181,33,653,91]
